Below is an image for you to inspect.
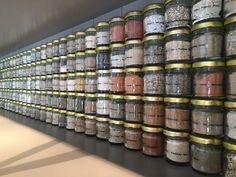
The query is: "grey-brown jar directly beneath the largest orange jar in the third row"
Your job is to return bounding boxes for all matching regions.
[125,95,143,123]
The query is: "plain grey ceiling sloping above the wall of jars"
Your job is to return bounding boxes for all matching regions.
[0,0,133,56]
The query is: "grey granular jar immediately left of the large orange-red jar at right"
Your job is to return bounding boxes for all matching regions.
[165,63,192,96]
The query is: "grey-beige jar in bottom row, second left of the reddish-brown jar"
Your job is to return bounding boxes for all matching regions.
[108,120,125,144]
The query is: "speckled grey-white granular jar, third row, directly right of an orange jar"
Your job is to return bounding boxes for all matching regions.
[143,66,165,95]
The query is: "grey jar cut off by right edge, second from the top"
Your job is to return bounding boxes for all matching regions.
[224,15,236,59]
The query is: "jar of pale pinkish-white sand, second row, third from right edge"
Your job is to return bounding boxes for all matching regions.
[165,28,191,63]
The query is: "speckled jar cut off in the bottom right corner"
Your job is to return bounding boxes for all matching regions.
[223,141,236,177]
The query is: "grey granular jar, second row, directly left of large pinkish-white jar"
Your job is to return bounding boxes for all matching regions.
[143,35,164,65]
